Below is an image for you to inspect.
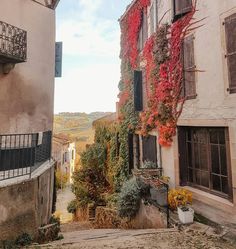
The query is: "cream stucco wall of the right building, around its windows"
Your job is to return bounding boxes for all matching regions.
[142,0,236,225]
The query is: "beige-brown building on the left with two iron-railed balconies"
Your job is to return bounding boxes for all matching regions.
[0,0,59,240]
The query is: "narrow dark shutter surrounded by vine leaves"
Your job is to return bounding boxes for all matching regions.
[134,71,143,111]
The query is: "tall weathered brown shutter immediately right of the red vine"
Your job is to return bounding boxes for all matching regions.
[182,35,197,99]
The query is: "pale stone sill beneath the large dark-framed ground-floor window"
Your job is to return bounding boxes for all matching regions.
[184,186,234,207]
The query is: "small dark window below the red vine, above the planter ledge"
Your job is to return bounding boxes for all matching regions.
[142,135,157,164]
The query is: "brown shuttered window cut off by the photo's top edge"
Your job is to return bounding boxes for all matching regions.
[173,0,192,21]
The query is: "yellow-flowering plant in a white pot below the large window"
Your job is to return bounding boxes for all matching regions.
[168,188,194,224]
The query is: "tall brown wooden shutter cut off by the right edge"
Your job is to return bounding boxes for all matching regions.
[224,13,236,93]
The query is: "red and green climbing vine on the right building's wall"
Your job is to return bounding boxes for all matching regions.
[119,0,196,146]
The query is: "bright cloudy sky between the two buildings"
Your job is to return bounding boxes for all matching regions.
[54,0,131,113]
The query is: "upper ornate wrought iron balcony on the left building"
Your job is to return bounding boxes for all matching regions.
[0,21,27,63]
